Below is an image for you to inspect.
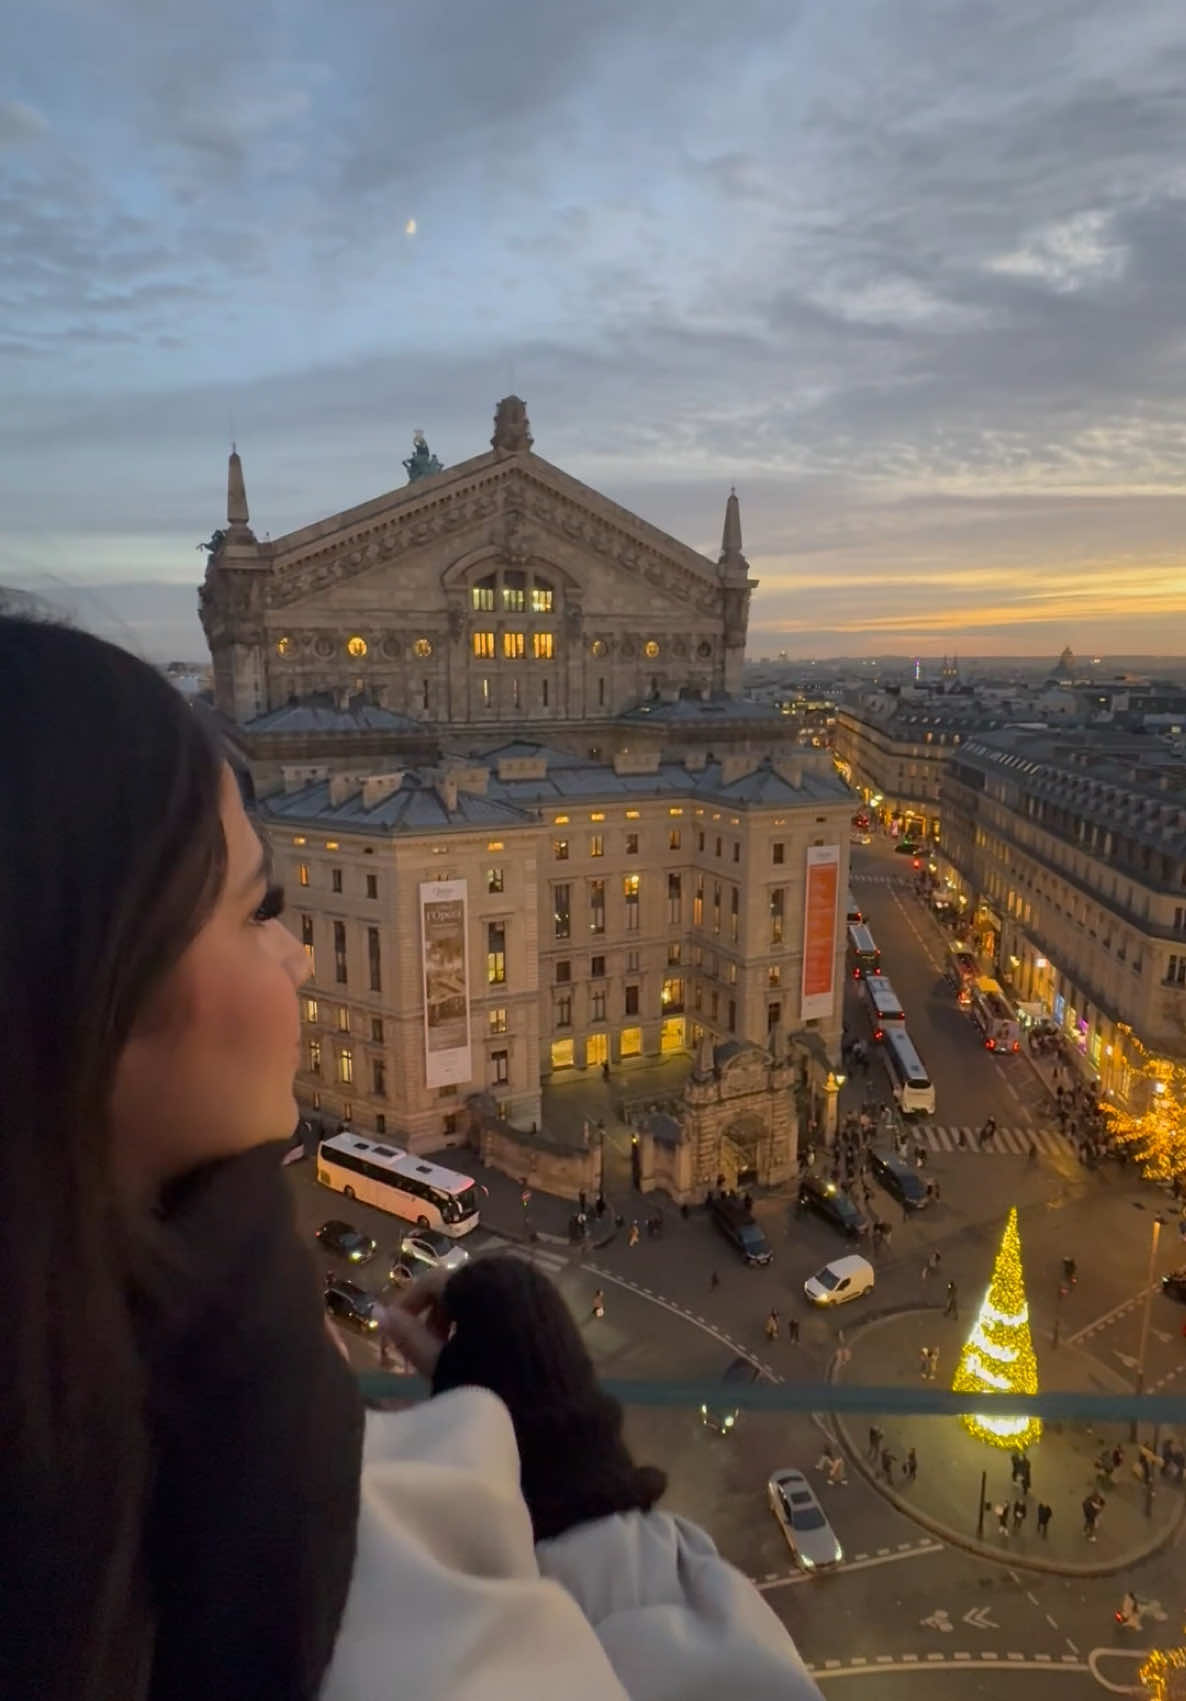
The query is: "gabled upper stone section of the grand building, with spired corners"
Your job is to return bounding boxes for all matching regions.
[193,396,754,733]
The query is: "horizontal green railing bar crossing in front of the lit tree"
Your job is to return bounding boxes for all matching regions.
[357,1371,1186,1425]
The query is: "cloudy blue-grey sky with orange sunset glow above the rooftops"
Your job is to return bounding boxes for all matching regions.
[0,0,1186,657]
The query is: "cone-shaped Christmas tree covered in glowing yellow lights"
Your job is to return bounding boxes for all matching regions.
[951,1206,1041,1449]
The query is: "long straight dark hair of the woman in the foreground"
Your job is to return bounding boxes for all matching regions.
[0,614,226,1701]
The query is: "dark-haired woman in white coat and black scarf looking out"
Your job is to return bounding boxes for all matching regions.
[0,616,815,1701]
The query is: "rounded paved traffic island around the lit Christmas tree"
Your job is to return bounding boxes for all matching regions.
[832,1305,1186,1577]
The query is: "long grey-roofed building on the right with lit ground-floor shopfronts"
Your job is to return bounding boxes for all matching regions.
[943,728,1186,1101]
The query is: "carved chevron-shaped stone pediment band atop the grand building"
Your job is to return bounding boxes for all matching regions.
[262,451,720,612]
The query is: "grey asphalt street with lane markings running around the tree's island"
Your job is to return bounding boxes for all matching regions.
[288,847,1186,1698]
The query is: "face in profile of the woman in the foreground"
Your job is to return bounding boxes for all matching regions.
[112,769,308,1196]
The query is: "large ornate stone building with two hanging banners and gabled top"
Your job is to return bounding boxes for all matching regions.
[201,396,852,1198]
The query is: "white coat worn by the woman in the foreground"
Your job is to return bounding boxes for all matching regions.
[322,1388,820,1701]
